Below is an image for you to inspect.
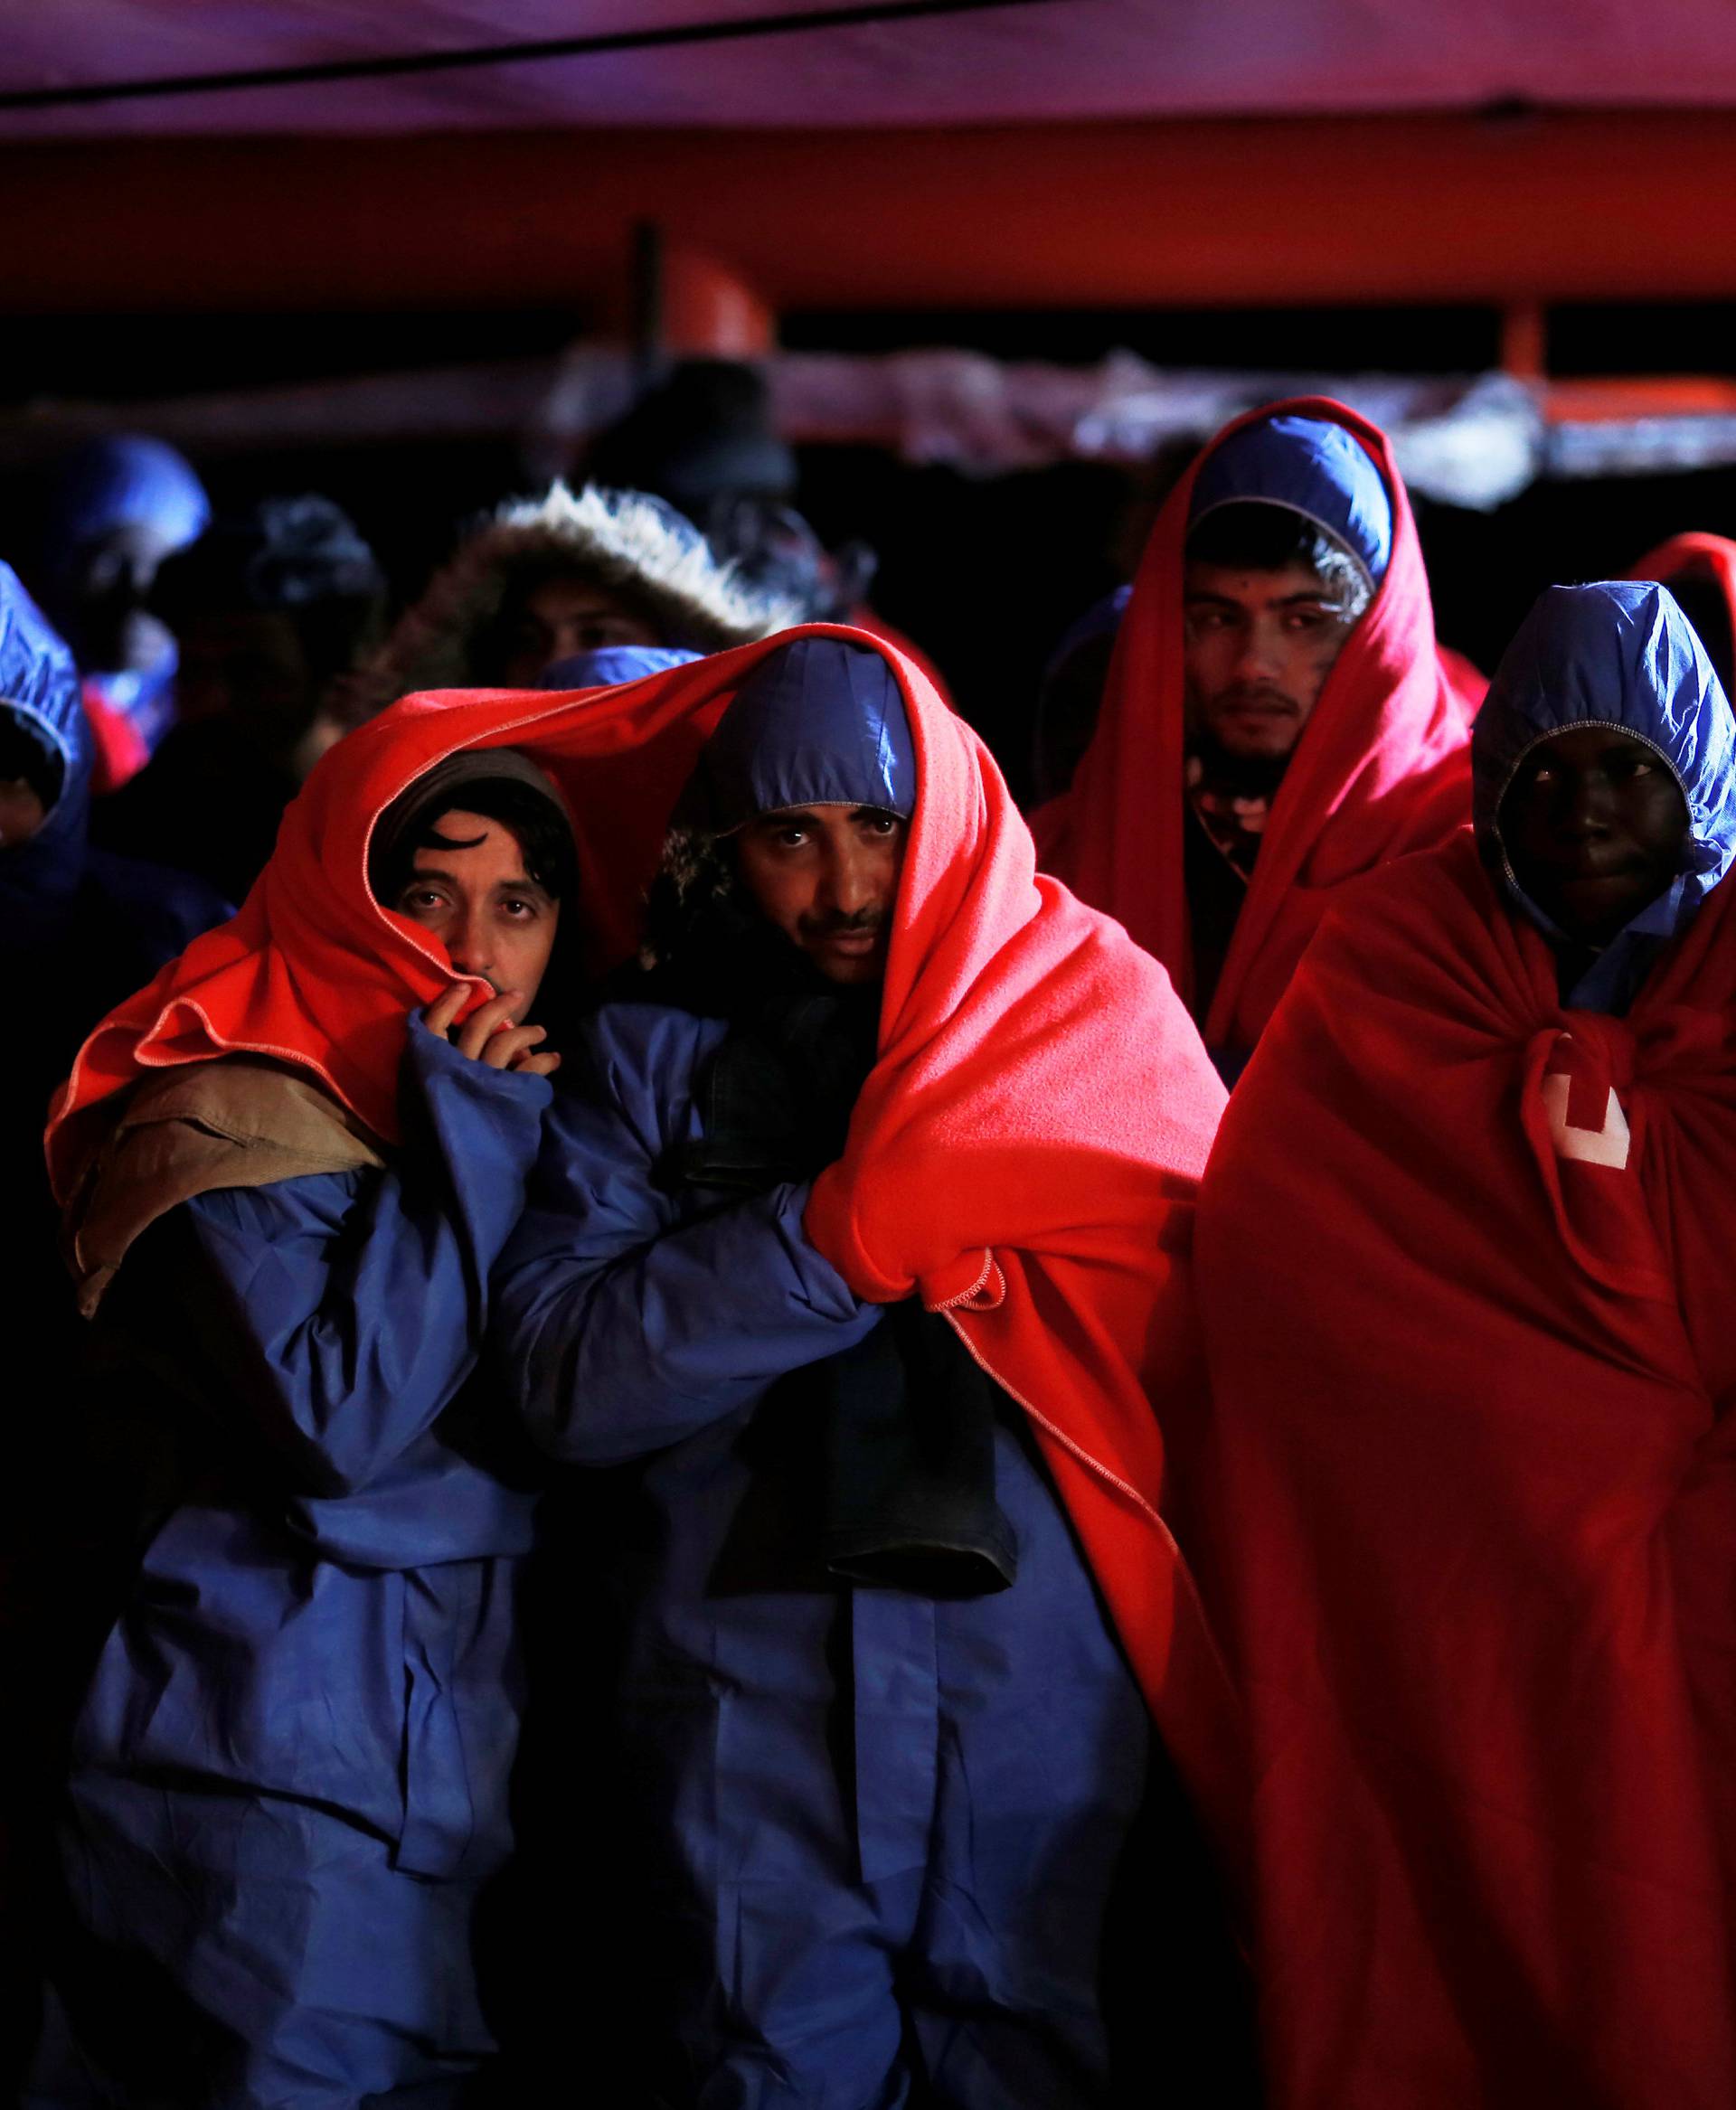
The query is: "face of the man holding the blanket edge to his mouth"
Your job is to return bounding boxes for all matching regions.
[384,806,561,1017]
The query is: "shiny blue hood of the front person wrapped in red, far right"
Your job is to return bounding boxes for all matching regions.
[1470,580,1736,1011]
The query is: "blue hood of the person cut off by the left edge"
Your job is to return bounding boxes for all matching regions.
[0,563,90,952]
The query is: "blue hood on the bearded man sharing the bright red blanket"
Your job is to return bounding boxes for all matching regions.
[696,637,915,835]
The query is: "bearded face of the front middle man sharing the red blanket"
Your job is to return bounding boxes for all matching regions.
[734,806,909,985]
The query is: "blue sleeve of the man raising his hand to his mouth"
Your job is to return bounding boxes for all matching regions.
[165,1019,551,1496]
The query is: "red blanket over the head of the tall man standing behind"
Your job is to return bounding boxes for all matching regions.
[1033,397,1470,1049]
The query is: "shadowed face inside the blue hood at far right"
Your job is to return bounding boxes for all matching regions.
[1500,726,1687,946]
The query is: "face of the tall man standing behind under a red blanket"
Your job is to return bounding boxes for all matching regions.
[1181,563,1356,762]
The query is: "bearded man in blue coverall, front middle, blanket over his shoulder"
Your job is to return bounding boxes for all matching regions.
[495,629,1241,2110]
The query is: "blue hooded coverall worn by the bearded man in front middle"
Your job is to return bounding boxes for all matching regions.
[495,639,1204,2110]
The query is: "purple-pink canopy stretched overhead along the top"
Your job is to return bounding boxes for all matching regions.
[0,0,1736,139]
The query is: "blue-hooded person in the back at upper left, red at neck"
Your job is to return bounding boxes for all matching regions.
[42,435,211,796]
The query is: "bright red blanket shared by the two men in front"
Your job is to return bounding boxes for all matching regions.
[49,625,1234,1811]
